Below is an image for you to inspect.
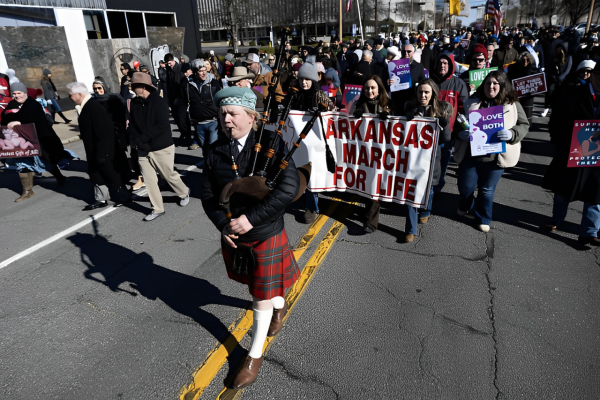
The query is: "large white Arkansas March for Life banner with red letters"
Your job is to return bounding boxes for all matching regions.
[282,111,438,207]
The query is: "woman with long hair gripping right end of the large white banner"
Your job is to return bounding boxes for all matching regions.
[404,79,453,243]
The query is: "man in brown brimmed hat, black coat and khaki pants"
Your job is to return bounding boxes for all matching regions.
[129,72,190,221]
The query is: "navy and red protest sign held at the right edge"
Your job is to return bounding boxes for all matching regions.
[567,120,600,168]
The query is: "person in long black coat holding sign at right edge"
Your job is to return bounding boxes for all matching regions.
[542,70,600,246]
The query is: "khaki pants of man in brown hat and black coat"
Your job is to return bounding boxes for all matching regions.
[138,145,189,214]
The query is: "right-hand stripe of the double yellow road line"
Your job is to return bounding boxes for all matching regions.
[217,203,356,400]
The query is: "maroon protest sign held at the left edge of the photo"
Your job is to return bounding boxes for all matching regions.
[0,124,42,158]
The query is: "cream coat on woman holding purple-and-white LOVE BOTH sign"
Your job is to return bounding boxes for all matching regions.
[453,96,529,168]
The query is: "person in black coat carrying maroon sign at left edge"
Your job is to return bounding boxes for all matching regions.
[2,82,73,202]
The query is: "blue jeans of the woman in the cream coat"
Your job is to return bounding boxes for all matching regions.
[458,156,504,225]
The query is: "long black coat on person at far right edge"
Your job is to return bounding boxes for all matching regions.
[542,85,600,204]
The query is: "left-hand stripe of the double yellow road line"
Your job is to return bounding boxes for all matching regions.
[179,206,339,400]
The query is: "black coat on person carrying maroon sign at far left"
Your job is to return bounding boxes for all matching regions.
[2,97,65,164]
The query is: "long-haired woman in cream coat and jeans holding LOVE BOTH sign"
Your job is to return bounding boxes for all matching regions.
[454,71,529,232]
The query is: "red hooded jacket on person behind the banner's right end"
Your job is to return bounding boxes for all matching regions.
[431,54,469,131]
